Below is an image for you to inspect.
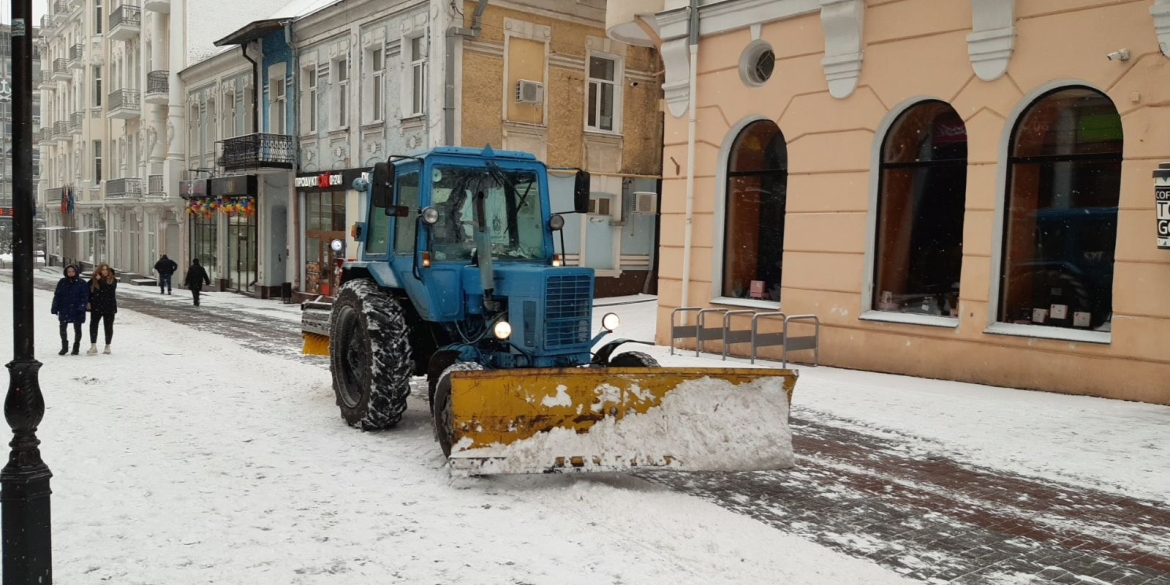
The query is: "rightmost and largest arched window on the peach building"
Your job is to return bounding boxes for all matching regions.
[999,87,1123,331]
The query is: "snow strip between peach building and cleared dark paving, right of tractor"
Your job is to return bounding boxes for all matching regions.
[594,297,1170,504]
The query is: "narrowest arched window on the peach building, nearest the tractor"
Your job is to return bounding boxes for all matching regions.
[722,121,789,302]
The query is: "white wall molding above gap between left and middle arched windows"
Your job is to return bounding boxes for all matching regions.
[820,0,866,99]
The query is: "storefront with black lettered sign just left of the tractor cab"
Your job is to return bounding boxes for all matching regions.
[294,168,366,296]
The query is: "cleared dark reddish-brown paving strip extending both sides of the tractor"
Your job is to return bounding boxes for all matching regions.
[20,275,1170,585]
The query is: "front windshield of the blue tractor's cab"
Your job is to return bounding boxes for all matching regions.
[431,165,546,262]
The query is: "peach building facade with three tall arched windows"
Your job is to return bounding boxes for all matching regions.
[607,0,1170,404]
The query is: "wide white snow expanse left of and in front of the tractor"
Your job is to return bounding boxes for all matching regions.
[0,282,903,584]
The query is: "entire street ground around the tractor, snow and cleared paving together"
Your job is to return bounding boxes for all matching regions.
[0,271,1170,585]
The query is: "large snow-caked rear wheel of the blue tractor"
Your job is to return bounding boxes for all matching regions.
[329,280,412,431]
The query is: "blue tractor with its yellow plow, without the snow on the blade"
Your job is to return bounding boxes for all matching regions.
[302,147,791,473]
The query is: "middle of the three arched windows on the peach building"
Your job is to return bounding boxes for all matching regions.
[873,101,966,317]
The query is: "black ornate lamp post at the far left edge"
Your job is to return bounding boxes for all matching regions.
[0,0,53,585]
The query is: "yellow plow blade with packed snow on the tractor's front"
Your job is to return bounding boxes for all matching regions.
[449,367,797,475]
